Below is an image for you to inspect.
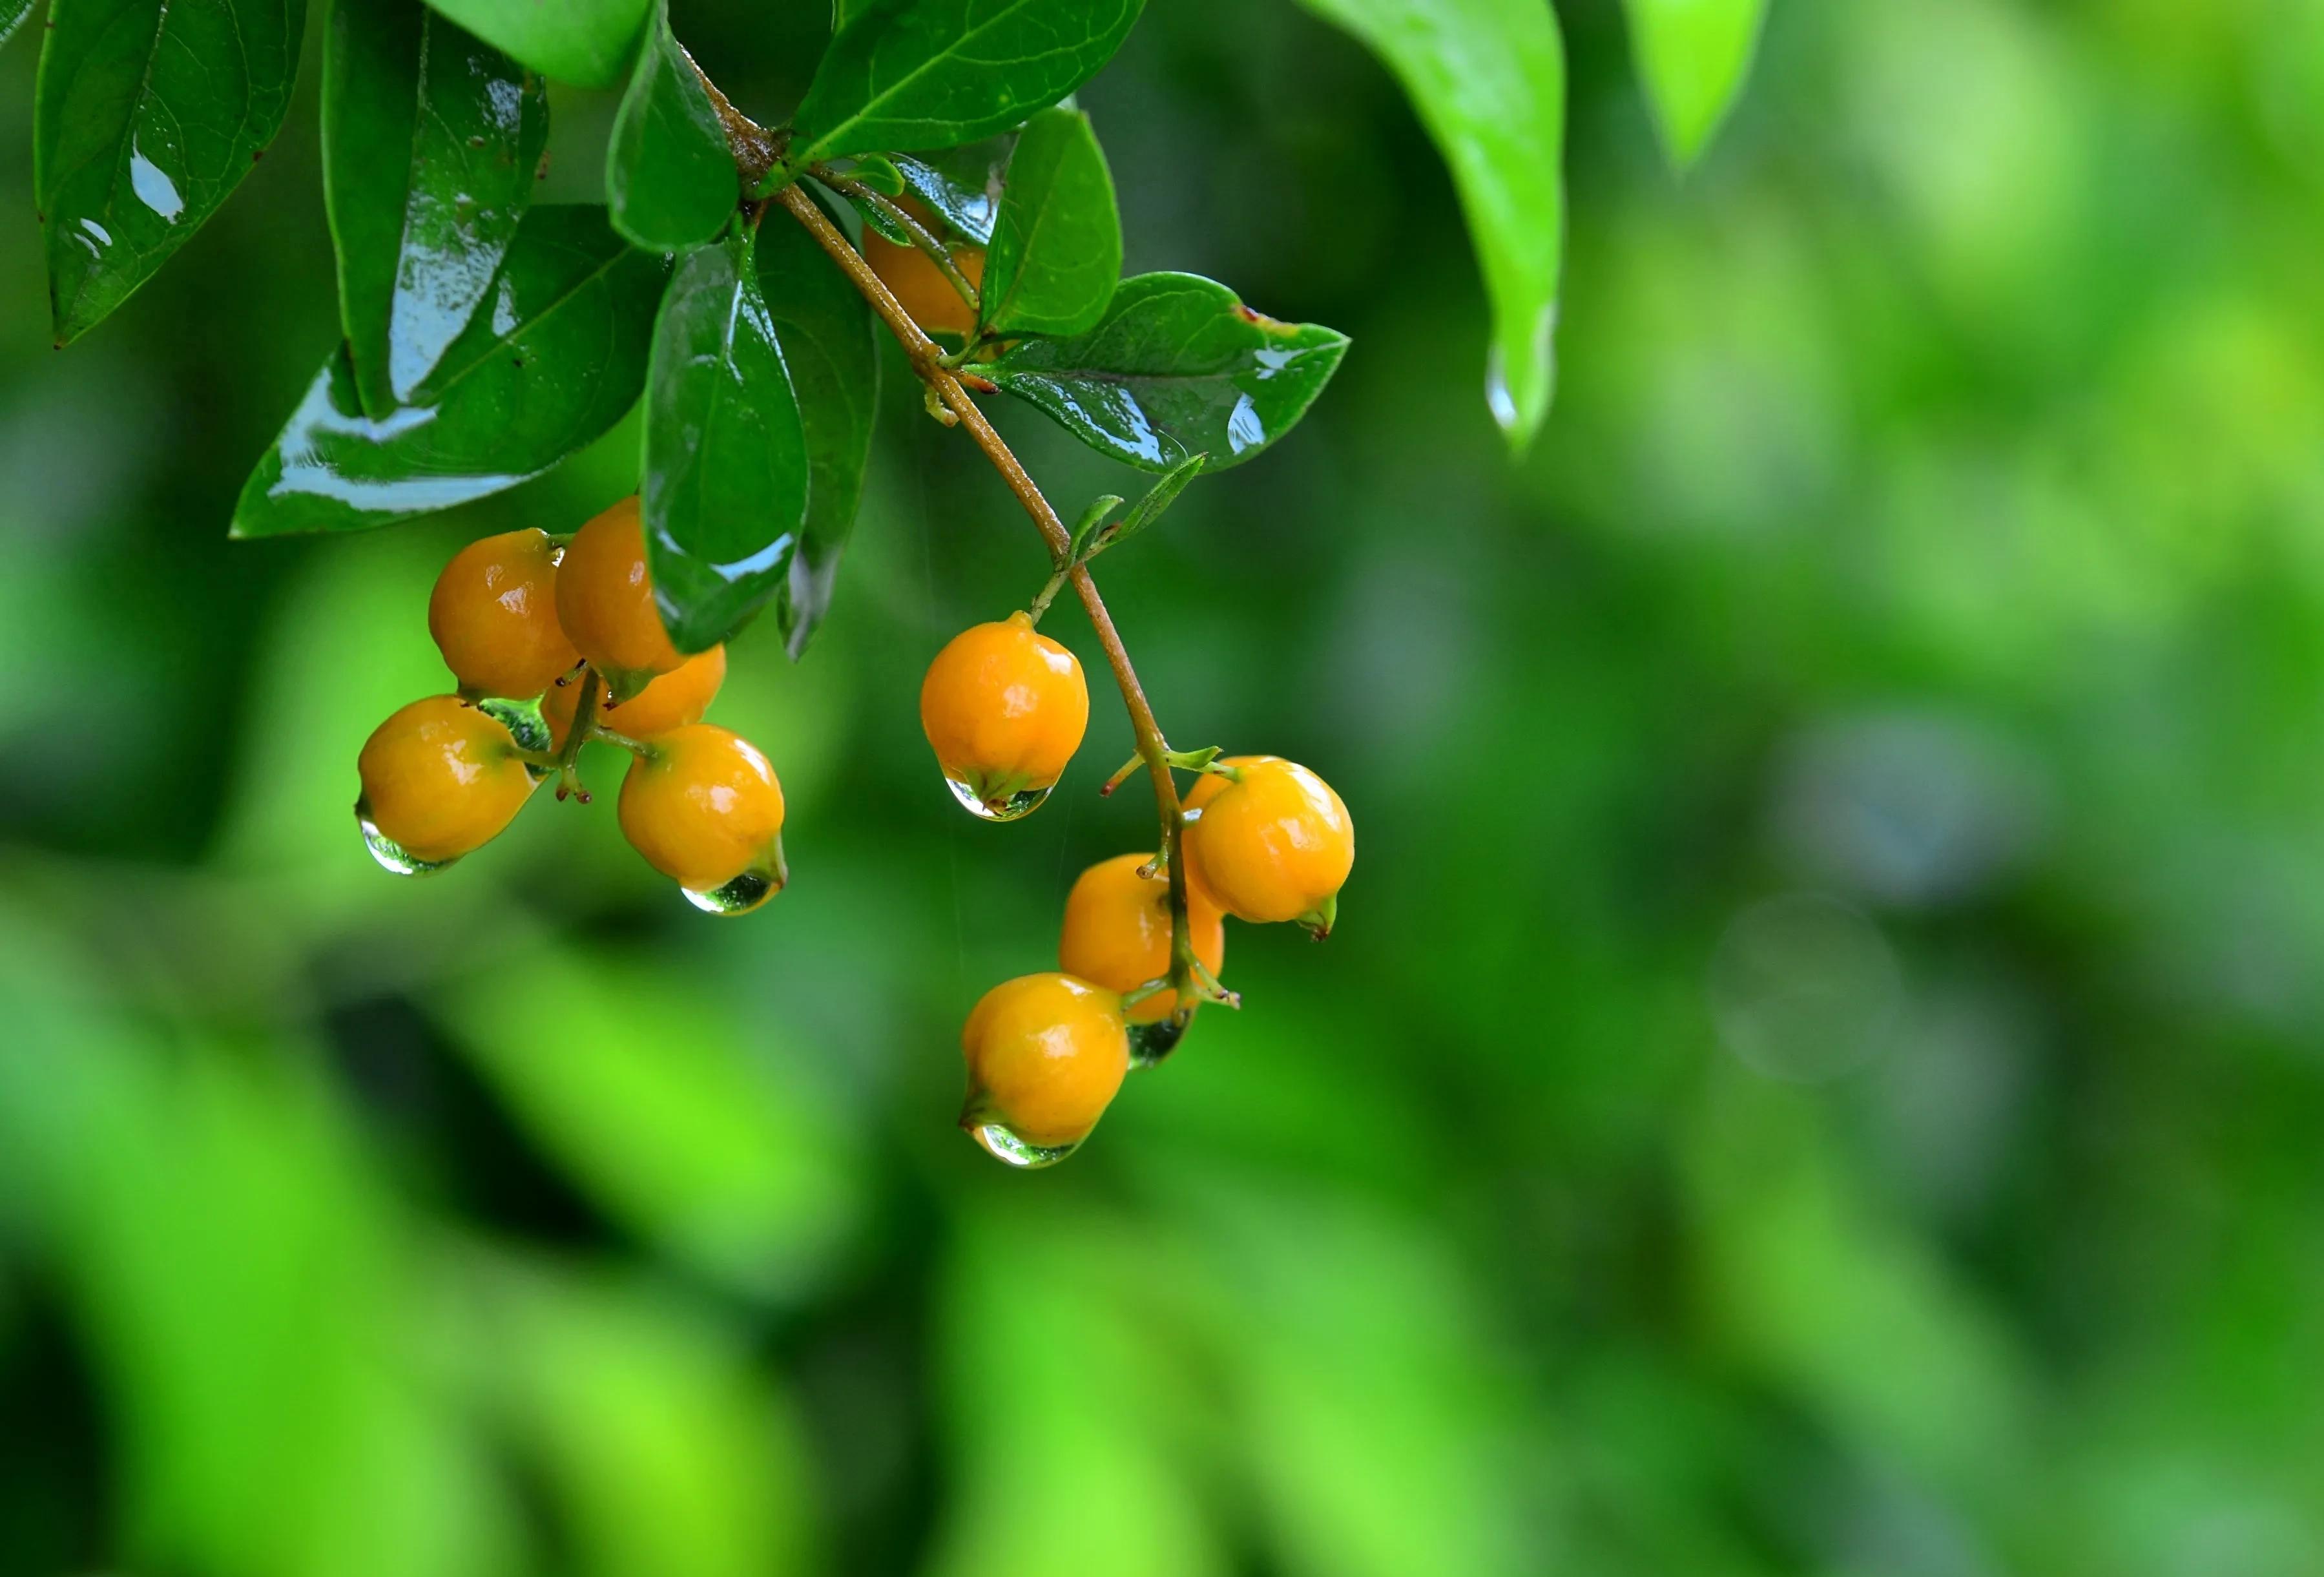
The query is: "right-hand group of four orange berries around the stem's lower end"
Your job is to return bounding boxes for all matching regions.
[920,614,1355,1165]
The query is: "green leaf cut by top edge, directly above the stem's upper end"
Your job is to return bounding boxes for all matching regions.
[788,0,1146,170]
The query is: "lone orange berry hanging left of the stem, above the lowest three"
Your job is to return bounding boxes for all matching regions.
[920,614,1090,812]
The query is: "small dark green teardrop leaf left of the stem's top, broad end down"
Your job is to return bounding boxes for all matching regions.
[604,0,742,251]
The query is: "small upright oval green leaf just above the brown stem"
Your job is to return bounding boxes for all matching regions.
[983,109,1123,335]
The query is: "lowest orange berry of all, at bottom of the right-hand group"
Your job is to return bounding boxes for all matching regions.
[960,975,1130,1149]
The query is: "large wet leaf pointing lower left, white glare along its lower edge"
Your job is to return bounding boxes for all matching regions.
[233,205,669,538]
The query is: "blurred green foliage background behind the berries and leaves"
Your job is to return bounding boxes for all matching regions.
[0,0,2324,1577]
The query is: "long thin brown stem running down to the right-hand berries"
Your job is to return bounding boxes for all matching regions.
[774,186,1197,1023]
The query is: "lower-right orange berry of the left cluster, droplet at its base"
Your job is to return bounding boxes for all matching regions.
[621,724,783,893]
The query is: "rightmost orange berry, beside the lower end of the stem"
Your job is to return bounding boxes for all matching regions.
[1185,756,1355,935]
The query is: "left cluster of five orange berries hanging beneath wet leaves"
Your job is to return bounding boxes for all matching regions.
[355,497,785,914]
